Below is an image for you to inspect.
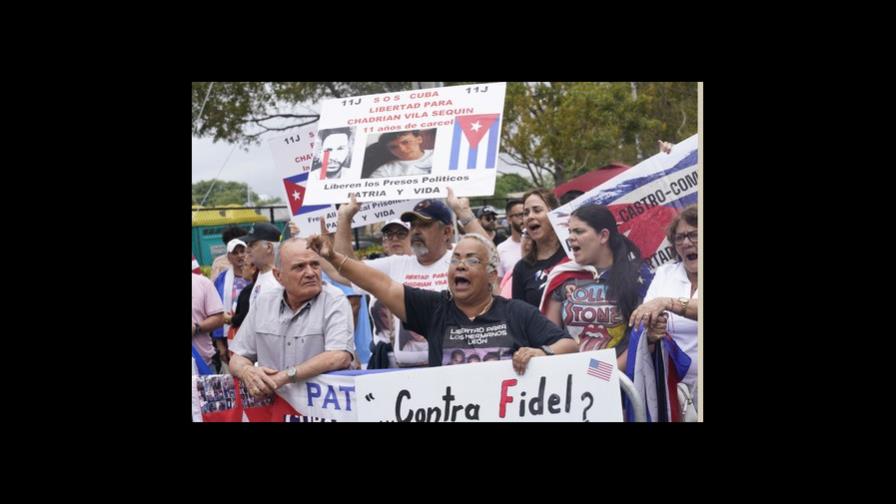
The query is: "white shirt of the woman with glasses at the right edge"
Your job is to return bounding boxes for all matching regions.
[644,262,698,390]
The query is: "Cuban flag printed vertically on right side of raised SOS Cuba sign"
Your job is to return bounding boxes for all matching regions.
[448,114,501,170]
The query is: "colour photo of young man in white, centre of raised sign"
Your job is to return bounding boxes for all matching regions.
[361,128,436,178]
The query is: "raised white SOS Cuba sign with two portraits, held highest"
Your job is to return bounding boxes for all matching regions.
[306,83,506,205]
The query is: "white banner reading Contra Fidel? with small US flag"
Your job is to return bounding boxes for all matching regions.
[355,349,622,422]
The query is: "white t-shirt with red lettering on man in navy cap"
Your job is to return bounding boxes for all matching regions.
[360,249,451,366]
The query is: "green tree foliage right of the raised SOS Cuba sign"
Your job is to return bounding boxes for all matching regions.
[501,82,697,187]
